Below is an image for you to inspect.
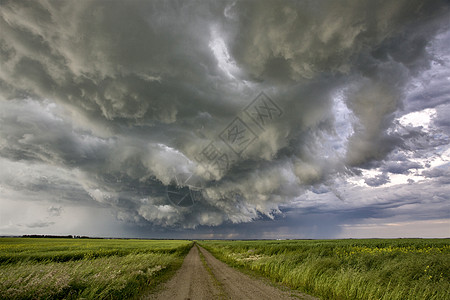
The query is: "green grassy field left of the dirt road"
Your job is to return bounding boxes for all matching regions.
[0,238,192,299]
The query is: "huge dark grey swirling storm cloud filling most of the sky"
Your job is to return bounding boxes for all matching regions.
[0,1,449,232]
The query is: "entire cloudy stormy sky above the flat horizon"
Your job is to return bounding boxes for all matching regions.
[0,0,450,239]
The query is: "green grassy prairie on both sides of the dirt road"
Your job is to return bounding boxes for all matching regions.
[0,238,450,300]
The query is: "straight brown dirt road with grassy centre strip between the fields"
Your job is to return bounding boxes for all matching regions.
[147,246,316,300]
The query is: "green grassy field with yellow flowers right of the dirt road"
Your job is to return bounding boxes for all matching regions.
[199,239,450,300]
